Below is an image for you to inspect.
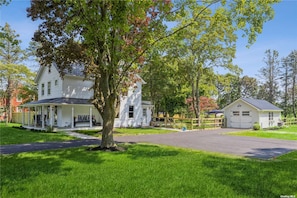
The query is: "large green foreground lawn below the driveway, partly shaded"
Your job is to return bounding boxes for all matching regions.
[0,144,297,198]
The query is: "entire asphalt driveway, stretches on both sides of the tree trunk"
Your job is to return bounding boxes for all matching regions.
[0,129,297,159]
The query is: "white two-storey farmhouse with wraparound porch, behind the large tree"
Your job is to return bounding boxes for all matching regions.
[22,66,153,130]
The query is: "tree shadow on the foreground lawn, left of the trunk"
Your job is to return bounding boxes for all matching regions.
[0,147,103,191]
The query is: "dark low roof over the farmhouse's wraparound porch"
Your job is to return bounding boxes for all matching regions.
[21,97,92,107]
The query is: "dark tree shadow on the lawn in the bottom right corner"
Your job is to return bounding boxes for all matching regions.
[203,152,297,197]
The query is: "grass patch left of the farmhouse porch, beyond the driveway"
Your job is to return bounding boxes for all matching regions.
[0,123,75,145]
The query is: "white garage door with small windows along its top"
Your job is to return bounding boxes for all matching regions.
[230,111,253,129]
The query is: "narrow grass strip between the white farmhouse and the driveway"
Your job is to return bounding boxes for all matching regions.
[76,128,174,137]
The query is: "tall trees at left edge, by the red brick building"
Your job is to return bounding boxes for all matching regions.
[0,23,37,122]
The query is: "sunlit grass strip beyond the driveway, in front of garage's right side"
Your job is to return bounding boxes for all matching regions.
[228,125,297,140]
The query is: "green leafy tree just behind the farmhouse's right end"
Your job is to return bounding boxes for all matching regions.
[141,45,189,116]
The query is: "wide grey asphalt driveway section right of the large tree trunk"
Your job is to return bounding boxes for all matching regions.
[115,129,297,159]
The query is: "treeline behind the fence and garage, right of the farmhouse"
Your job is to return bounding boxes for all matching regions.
[142,50,297,118]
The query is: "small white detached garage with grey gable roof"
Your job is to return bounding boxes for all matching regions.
[223,98,282,128]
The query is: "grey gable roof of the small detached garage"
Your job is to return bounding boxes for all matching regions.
[224,98,282,111]
